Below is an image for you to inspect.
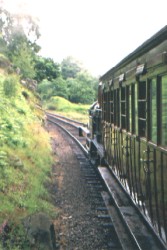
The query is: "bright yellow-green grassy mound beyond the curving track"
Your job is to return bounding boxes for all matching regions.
[45,96,90,123]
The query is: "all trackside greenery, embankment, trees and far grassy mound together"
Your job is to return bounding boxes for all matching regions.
[0,3,98,250]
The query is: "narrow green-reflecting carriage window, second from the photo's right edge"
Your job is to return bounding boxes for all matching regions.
[149,79,157,143]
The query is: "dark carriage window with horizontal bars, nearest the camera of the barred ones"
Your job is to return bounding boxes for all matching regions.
[138,81,146,137]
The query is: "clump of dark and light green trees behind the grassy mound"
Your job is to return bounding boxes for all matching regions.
[35,57,98,104]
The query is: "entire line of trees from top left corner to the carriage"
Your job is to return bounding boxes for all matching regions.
[0,8,97,103]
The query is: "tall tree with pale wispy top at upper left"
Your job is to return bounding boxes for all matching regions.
[0,8,40,78]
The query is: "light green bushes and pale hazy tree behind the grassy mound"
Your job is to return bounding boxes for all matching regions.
[38,57,98,104]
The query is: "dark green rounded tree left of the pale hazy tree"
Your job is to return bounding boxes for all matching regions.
[35,56,60,82]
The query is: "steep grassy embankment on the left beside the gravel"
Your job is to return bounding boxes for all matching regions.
[0,69,56,249]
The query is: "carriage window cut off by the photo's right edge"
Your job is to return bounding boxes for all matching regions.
[161,76,167,146]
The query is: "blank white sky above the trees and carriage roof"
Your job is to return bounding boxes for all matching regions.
[0,0,167,77]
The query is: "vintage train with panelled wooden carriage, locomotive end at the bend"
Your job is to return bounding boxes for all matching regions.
[88,26,167,245]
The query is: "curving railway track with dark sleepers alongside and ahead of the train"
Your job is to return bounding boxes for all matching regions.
[46,113,166,250]
